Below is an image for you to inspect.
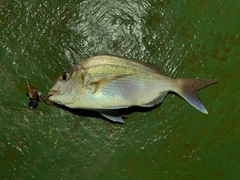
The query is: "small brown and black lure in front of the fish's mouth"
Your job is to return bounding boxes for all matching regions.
[27,81,39,109]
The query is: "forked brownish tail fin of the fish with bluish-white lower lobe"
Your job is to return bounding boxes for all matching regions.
[175,78,216,114]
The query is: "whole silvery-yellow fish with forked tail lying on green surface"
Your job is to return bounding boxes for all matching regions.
[48,55,216,123]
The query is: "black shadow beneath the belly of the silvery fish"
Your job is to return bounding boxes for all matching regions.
[54,103,162,124]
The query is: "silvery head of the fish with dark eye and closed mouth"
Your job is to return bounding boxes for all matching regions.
[48,66,83,106]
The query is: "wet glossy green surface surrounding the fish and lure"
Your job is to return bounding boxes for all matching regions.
[0,0,240,180]
